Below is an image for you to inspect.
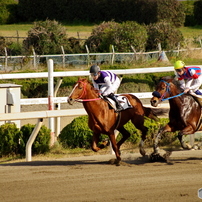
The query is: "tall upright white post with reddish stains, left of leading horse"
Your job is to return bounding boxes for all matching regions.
[48,59,55,146]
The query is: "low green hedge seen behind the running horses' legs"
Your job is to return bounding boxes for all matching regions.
[59,116,177,149]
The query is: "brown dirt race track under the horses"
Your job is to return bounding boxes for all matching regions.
[0,150,202,202]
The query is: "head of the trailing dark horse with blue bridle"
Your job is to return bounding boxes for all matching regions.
[150,77,173,107]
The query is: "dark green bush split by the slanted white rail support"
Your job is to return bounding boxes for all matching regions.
[20,124,51,154]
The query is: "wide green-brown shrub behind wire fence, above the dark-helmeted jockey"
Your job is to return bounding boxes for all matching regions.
[86,21,147,52]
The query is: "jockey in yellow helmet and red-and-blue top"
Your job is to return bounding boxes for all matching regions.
[174,60,202,95]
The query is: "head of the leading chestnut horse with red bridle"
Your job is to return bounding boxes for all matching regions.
[67,79,89,105]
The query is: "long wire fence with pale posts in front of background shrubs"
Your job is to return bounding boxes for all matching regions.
[0,45,202,72]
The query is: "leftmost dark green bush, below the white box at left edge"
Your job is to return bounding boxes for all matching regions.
[0,123,24,157]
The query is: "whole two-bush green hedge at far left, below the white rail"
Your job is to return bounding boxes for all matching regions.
[0,123,50,157]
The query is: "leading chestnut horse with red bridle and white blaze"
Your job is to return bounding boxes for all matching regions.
[68,79,156,164]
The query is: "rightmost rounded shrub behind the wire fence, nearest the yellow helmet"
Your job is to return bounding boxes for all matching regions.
[146,21,183,51]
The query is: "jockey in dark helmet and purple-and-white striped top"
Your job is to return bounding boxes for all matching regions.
[90,65,123,111]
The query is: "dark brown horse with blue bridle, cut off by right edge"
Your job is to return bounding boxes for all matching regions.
[151,77,202,153]
